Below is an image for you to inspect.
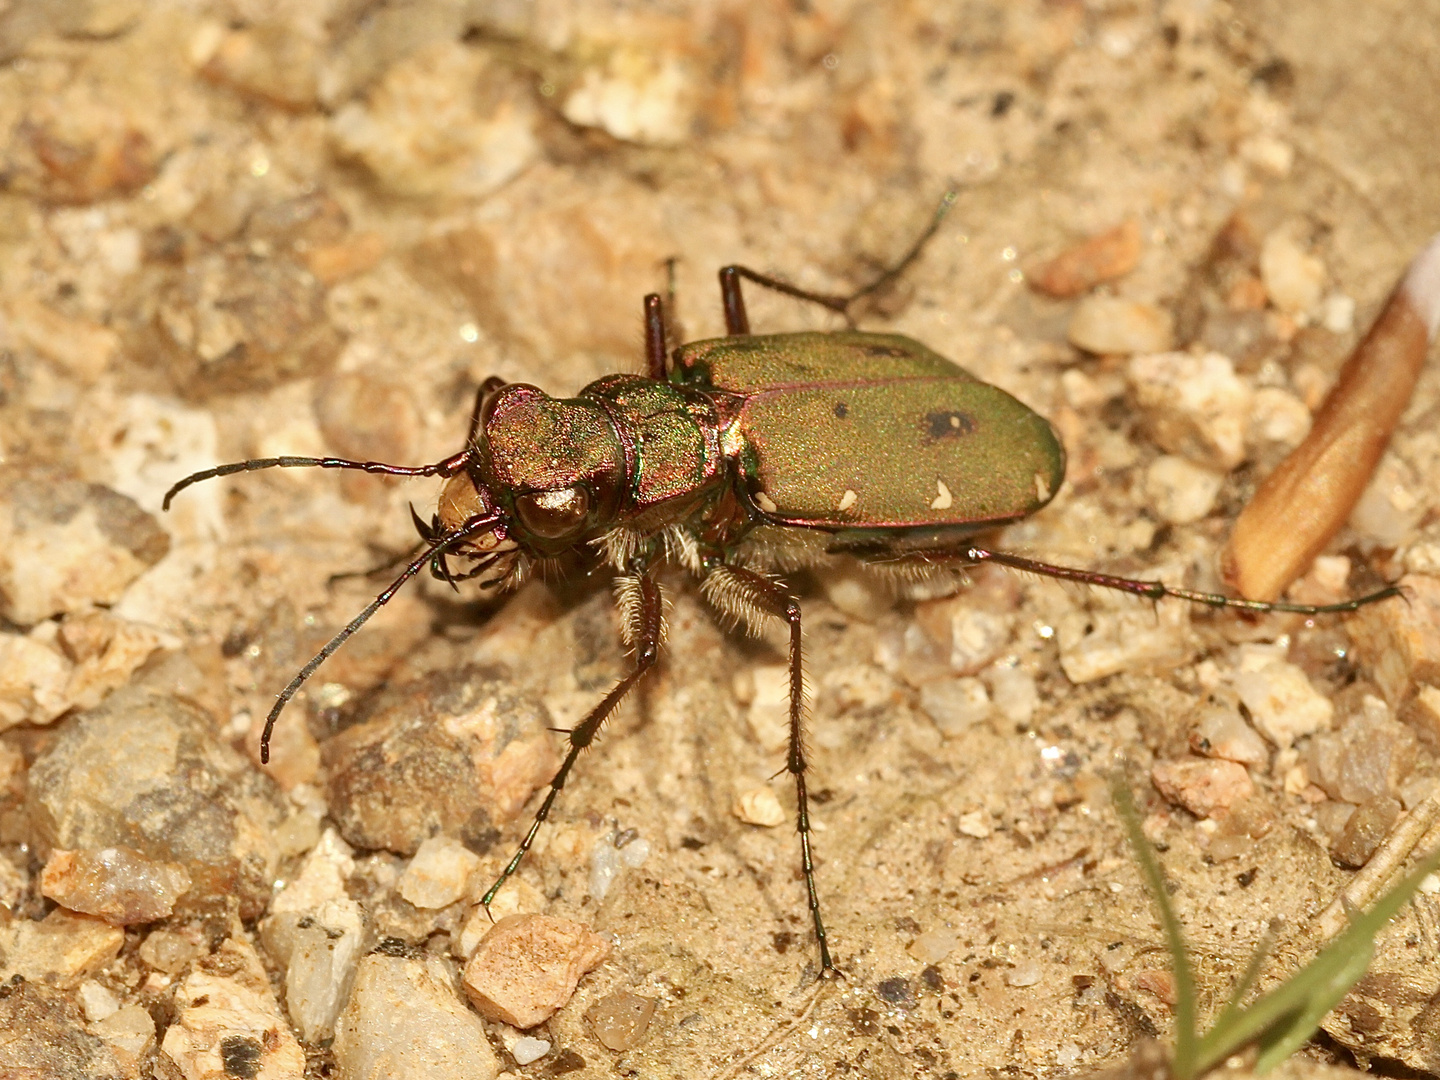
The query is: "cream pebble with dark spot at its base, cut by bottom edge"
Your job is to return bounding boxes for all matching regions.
[160,937,305,1080]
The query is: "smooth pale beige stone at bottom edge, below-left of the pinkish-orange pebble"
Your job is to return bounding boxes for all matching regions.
[334,946,500,1080]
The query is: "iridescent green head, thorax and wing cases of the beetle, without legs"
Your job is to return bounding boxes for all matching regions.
[477,331,1066,550]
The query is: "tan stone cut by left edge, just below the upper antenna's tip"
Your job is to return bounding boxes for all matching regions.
[0,465,170,626]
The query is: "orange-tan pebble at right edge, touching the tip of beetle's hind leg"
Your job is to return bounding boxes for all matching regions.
[1346,575,1440,707]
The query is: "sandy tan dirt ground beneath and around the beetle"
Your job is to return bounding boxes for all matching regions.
[0,0,1440,1077]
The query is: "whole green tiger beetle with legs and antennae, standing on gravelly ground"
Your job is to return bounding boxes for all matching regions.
[164,193,1398,976]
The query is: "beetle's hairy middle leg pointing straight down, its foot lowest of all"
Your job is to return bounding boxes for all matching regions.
[701,564,840,976]
